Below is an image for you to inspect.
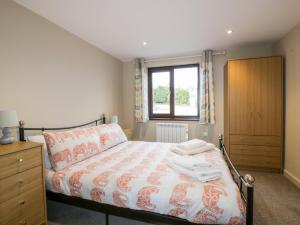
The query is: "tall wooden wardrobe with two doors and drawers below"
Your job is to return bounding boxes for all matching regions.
[224,56,283,172]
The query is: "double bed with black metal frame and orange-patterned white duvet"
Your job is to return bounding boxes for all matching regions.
[20,115,254,225]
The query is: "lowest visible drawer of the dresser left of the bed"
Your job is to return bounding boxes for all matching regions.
[0,185,45,225]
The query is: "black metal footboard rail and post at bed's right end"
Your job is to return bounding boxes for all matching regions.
[219,134,255,225]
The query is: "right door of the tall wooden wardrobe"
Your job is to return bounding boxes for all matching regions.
[251,57,282,136]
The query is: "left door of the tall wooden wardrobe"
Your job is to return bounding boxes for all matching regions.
[228,60,254,135]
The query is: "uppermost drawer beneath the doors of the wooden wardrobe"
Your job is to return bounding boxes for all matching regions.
[230,135,281,147]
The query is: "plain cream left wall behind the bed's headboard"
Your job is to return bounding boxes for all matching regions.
[0,0,122,130]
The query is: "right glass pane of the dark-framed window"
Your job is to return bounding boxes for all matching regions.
[174,67,198,116]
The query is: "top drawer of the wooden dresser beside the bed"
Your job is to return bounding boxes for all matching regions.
[0,147,42,179]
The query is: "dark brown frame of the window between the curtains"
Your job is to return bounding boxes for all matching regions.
[148,63,200,121]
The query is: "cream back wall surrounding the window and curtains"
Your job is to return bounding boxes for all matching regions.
[123,45,272,144]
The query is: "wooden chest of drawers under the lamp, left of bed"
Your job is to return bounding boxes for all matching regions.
[0,142,47,225]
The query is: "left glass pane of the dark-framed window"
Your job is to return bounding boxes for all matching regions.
[152,71,170,114]
